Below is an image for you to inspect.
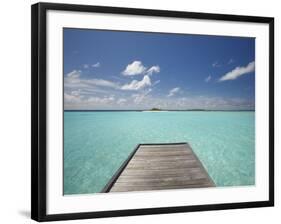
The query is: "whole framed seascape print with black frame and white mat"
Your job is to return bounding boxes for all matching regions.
[31,3,274,221]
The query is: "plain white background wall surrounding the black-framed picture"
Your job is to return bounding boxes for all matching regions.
[0,0,276,224]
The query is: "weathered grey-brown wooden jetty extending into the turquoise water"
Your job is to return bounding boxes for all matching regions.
[102,143,215,192]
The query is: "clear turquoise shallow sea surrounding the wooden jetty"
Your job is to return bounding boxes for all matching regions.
[64,111,255,194]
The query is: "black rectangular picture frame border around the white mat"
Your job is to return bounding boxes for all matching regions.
[31,3,274,221]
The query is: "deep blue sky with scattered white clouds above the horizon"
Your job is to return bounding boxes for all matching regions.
[63,28,255,110]
